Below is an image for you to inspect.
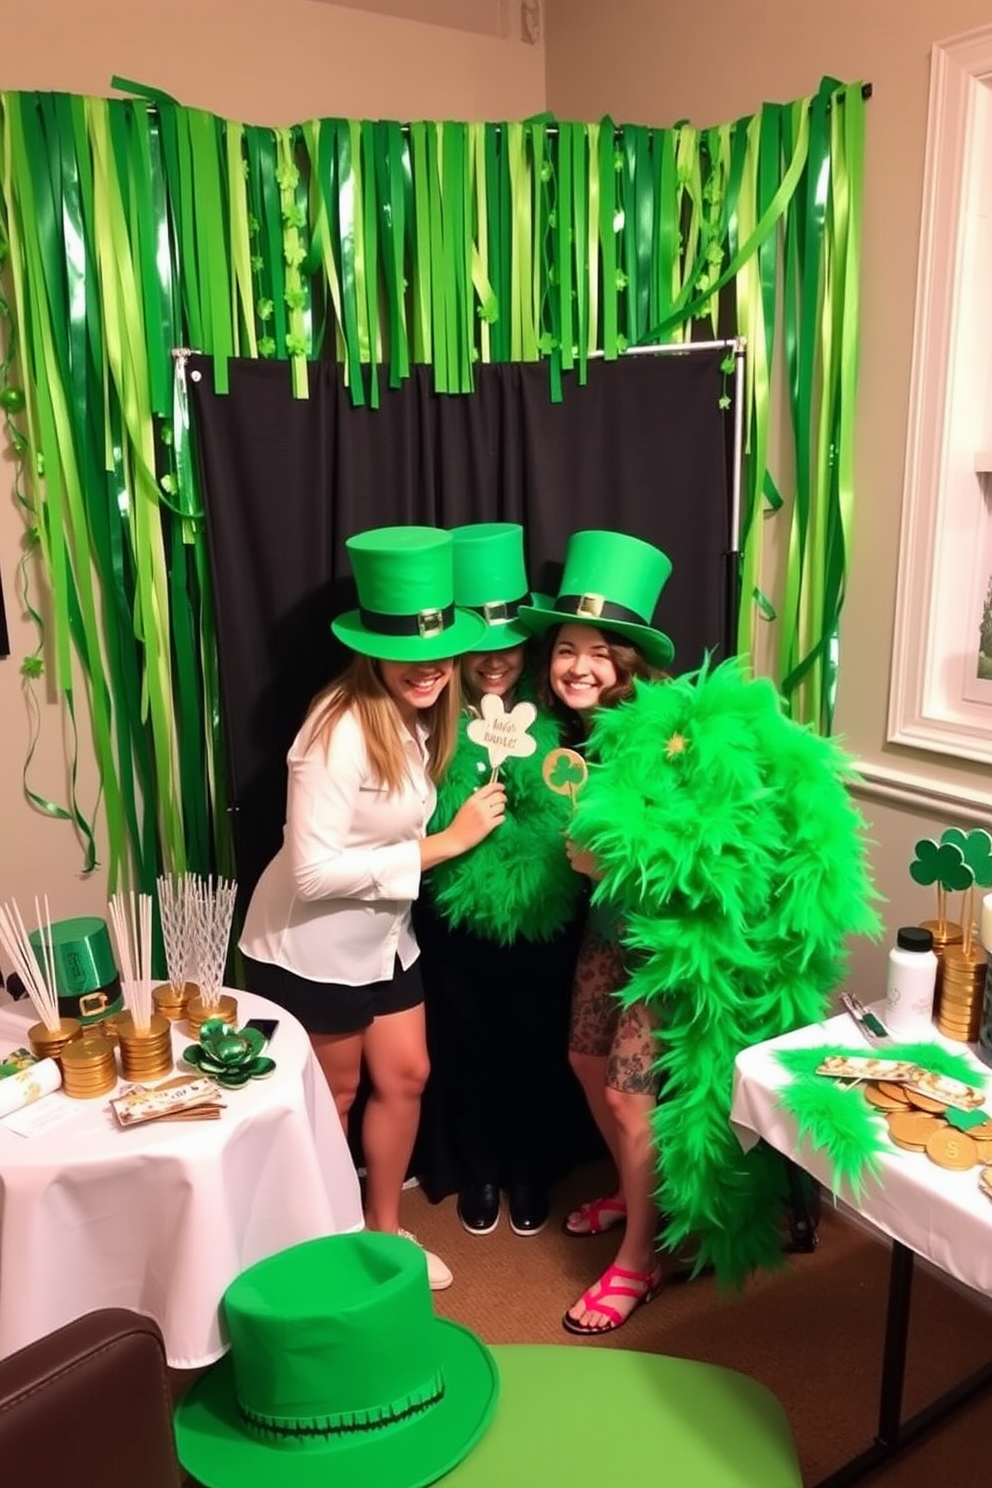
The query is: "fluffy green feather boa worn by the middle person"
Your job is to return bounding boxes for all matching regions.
[428,711,584,945]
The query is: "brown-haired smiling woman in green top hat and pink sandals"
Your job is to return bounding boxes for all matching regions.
[521,531,674,1335]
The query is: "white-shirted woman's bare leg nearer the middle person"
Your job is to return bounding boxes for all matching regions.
[361,1003,428,1234]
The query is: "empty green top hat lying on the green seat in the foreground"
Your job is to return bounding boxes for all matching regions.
[175,1231,498,1488]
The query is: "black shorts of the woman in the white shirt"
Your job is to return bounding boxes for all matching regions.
[244,955,424,1034]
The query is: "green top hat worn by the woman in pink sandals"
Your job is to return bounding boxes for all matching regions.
[521,531,675,667]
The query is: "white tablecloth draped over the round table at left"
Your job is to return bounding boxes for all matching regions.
[0,992,363,1369]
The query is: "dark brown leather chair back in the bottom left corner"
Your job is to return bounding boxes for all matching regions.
[0,1308,184,1488]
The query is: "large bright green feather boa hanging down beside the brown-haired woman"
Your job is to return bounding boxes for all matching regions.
[571,661,877,1283]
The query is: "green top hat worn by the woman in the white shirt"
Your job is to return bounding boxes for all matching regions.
[330,527,485,661]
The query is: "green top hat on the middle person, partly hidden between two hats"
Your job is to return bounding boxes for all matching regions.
[451,522,543,652]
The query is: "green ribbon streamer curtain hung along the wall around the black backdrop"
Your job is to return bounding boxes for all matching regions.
[0,79,864,891]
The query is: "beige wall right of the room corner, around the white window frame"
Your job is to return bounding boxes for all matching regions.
[544,0,992,991]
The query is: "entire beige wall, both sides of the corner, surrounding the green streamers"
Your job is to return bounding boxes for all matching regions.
[0,0,992,990]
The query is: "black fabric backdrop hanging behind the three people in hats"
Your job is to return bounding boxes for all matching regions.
[187,348,733,902]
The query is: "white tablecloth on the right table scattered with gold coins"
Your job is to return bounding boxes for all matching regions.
[730,1013,992,1296]
